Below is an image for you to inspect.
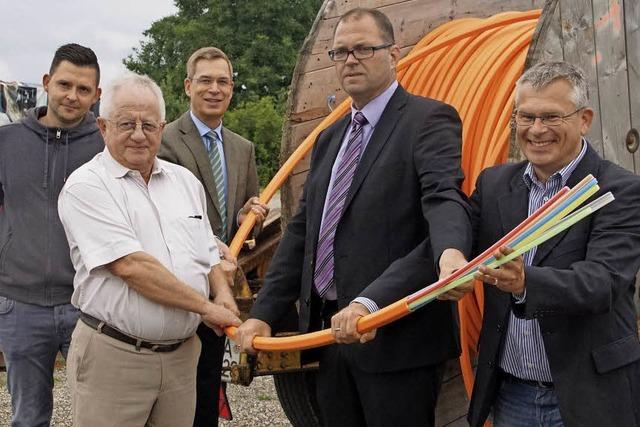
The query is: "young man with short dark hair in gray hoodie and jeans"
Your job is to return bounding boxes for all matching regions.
[0,44,104,427]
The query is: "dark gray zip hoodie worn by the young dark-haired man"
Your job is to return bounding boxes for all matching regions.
[0,107,104,306]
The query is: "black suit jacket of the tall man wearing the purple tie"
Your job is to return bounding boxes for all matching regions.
[251,87,471,372]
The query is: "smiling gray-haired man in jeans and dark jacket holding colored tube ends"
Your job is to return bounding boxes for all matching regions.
[469,62,640,427]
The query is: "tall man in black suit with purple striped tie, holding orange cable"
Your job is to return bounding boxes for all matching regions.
[238,9,471,426]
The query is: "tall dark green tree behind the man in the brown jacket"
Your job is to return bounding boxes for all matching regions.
[124,0,322,120]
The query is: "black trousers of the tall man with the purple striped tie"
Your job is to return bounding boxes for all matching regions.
[316,303,445,427]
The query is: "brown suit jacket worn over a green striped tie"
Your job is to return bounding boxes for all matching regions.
[158,111,259,240]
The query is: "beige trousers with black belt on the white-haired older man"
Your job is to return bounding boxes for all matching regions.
[67,320,200,427]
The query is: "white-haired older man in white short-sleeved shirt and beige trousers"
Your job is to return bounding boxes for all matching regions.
[58,74,240,426]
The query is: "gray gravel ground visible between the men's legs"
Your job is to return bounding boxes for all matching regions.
[0,367,291,427]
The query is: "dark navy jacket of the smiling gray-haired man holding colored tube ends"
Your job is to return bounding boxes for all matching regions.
[469,147,640,427]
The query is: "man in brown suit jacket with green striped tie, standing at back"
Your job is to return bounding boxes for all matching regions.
[158,47,269,427]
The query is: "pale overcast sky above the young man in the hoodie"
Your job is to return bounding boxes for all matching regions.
[0,0,177,87]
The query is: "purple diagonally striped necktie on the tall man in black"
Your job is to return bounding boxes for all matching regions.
[313,112,367,297]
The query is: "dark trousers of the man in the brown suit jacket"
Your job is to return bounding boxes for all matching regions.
[193,323,225,427]
